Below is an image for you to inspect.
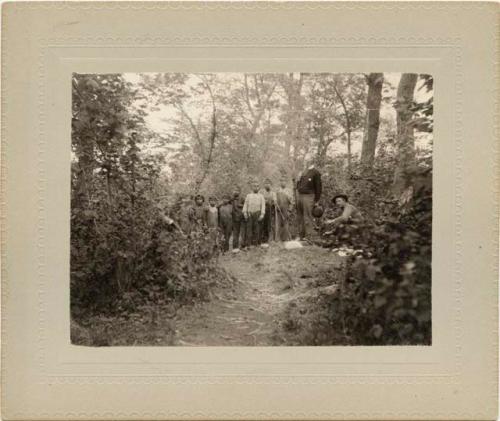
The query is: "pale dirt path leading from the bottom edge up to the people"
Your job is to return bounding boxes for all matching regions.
[175,244,341,346]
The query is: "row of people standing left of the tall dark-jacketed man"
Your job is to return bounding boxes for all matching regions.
[180,177,294,253]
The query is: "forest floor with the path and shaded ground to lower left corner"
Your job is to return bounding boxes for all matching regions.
[71,243,344,346]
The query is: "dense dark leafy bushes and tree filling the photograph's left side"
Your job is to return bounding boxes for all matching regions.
[71,75,225,319]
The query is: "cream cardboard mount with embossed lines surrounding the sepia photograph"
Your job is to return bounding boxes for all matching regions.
[2,2,499,420]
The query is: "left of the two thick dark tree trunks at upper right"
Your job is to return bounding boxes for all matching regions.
[361,73,384,171]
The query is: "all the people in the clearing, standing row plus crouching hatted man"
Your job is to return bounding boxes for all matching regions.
[174,165,360,253]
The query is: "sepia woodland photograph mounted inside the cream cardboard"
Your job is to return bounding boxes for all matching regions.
[70,69,433,346]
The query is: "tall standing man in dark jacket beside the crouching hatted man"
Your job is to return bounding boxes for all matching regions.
[296,164,322,240]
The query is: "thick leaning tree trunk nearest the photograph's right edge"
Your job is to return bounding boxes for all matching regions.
[393,73,418,196]
